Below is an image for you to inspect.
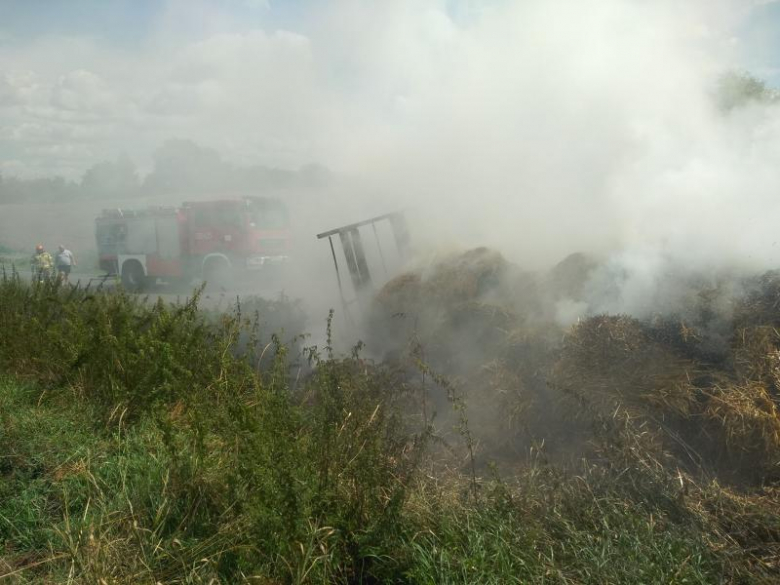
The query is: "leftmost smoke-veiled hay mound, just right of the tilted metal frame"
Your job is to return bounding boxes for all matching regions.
[368,248,560,454]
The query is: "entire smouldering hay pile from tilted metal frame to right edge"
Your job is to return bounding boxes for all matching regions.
[376,248,780,483]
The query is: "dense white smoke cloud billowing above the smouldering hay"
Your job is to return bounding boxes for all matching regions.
[336,1,778,266]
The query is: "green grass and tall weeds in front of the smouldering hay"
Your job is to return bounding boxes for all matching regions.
[0,276,780,584]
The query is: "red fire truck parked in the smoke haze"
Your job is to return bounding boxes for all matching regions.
[95,197,290,291]
